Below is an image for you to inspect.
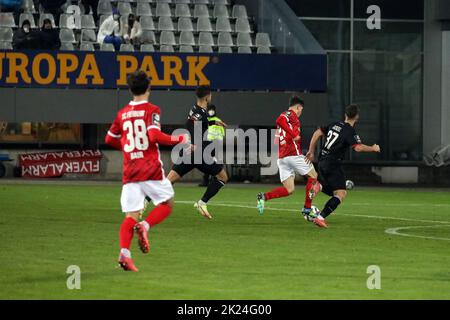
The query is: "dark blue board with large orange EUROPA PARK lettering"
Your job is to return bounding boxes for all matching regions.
[0,51,327,92]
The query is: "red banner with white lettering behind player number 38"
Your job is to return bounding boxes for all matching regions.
[18,150,103,178]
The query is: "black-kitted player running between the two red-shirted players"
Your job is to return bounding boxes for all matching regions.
[167,85,228,219]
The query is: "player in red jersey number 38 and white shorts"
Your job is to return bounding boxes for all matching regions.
[105,71,188,272]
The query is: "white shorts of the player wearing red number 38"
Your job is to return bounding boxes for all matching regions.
[120,178,175,213]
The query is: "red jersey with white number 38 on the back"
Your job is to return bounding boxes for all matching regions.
[108,101,164,184]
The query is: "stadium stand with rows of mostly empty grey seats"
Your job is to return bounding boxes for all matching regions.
[0,0,275,53]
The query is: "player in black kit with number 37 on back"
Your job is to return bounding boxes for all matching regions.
[306,105,380,228]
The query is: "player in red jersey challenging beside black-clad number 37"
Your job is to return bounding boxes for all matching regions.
[257,95,320,221]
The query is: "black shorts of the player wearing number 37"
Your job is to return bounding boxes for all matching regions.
[318,160,346,196]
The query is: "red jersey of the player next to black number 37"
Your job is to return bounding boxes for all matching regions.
[276,110,302,159]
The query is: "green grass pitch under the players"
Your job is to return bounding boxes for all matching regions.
[0,183,450,299]
